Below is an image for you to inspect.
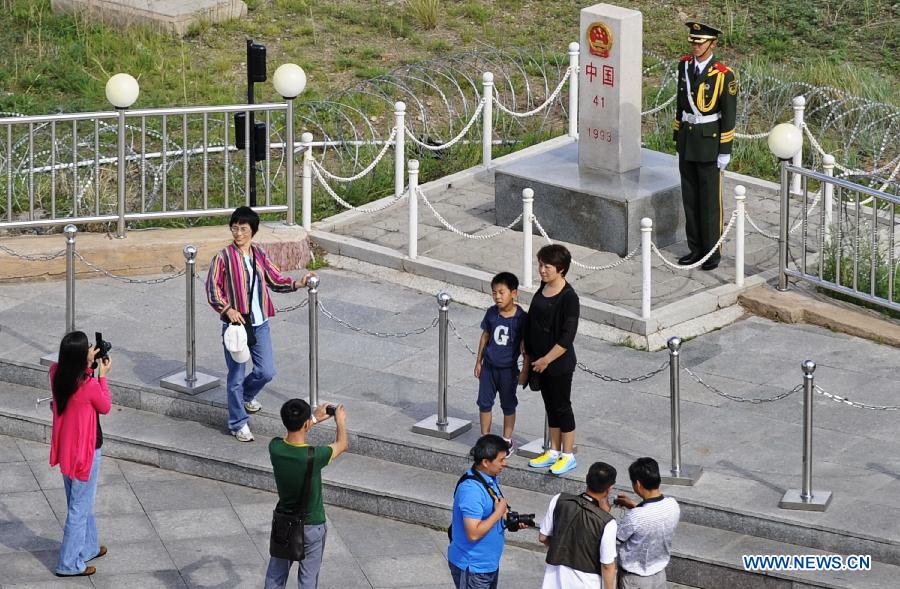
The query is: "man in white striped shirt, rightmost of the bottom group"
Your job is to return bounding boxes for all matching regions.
[615,457,681,589]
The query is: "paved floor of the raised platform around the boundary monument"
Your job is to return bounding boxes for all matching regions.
[331,171,778,313]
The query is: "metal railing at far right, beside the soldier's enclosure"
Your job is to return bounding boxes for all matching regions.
[778,162,900,311]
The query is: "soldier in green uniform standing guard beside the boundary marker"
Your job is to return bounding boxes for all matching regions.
[674,22,738,270]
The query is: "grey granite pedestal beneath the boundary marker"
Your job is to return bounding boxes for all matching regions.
[494,143,684,256]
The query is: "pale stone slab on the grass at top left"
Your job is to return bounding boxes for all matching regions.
[50,0,247,37]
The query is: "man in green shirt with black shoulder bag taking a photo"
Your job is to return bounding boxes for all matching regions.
[265,399,349,589]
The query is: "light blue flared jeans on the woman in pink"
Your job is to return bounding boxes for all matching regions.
[56,448,100,575]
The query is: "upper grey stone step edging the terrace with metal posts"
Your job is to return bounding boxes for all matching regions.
[0,360,900,565]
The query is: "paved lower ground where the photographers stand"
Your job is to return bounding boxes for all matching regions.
[0,436,704,589]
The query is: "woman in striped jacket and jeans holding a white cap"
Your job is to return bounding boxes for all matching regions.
[206,207,313,442]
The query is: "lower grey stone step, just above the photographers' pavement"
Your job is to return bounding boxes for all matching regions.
[0,384,900,589]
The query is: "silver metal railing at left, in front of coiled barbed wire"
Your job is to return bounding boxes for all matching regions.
[0,100,299,237]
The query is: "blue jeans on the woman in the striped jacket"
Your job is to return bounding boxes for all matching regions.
[222,321,275,432]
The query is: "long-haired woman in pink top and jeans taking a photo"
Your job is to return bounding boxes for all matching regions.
[50,331,112,577]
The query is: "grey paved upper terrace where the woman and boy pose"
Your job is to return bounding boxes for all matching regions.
[0,262,900,542]
